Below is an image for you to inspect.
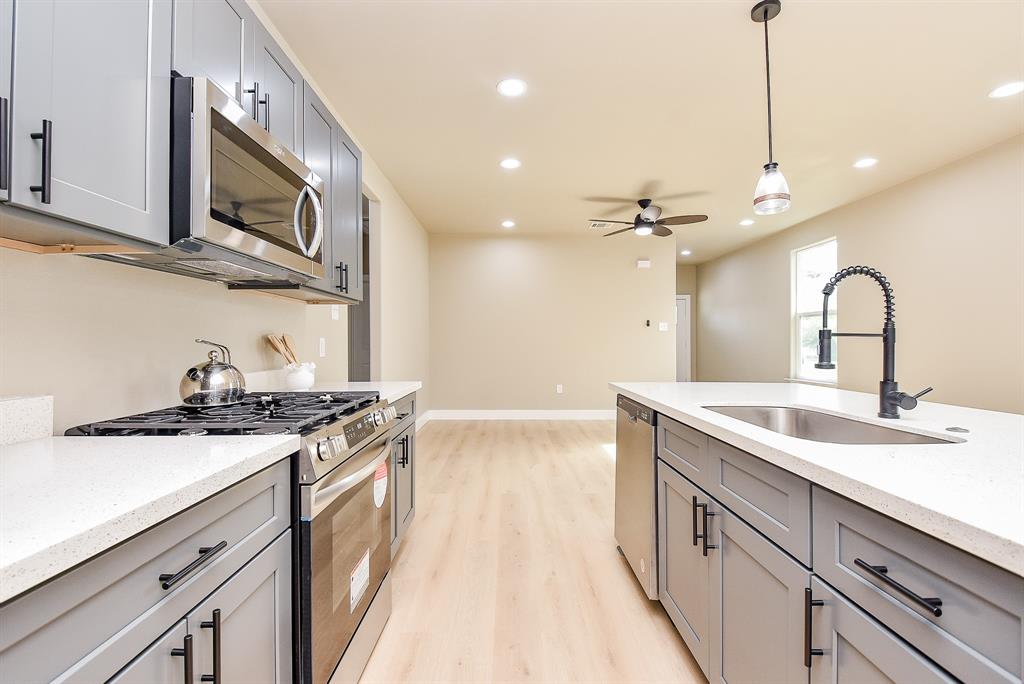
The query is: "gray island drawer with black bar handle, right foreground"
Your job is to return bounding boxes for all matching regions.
[813,486,1024,682]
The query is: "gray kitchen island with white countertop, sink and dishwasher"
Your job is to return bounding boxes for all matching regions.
[610,383,1024,684]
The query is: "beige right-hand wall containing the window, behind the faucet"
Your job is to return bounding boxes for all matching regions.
[697,137,1024,413]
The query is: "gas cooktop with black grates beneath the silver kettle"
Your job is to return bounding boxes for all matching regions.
[65,392,378,436]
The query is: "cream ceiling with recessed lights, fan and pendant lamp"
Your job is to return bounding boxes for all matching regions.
[260,0,1024,263]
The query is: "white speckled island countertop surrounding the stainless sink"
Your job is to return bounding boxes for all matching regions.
[610,382,1024,576]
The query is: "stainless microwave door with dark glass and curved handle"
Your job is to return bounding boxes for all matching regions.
[175,78,326,277]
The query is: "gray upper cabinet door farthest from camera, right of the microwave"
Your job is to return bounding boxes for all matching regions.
[333,126,364,301]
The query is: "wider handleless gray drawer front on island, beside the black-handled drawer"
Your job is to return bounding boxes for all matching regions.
[705,438,811,567]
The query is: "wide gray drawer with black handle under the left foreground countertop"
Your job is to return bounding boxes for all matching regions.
[0,460,291,682]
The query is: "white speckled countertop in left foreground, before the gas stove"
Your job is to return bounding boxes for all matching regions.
[0,435,299,603]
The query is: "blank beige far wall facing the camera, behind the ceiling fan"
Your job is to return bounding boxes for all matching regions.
[430,234,675,410]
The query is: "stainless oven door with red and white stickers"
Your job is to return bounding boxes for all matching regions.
[299,435,391,684]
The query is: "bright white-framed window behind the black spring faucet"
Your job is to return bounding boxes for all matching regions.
[792,238,839,383]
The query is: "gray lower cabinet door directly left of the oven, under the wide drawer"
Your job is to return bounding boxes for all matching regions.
[187,530,292,684]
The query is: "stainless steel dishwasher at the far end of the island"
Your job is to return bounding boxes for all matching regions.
[615,394,657,600]
